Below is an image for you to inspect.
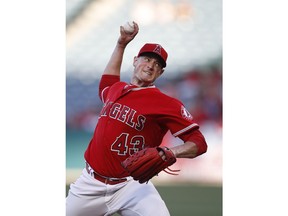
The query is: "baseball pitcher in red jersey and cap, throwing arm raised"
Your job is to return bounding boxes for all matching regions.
[66,22,207,216]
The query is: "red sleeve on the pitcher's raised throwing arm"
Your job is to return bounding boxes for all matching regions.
[99,74,120,103]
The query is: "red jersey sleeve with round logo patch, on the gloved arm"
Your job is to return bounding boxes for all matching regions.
[158,98,199,137]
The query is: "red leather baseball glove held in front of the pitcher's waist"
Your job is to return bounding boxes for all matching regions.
[122,147,180,184]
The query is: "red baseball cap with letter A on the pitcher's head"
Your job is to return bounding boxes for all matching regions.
[137,43,168,67]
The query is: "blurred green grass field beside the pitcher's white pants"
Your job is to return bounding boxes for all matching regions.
[66,184,222,216]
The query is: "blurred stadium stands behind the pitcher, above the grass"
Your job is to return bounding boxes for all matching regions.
[66,0,222,216]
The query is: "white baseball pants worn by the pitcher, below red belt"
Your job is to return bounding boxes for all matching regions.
[66,169,170,216]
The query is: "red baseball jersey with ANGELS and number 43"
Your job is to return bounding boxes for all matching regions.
[84,75,199,178]
